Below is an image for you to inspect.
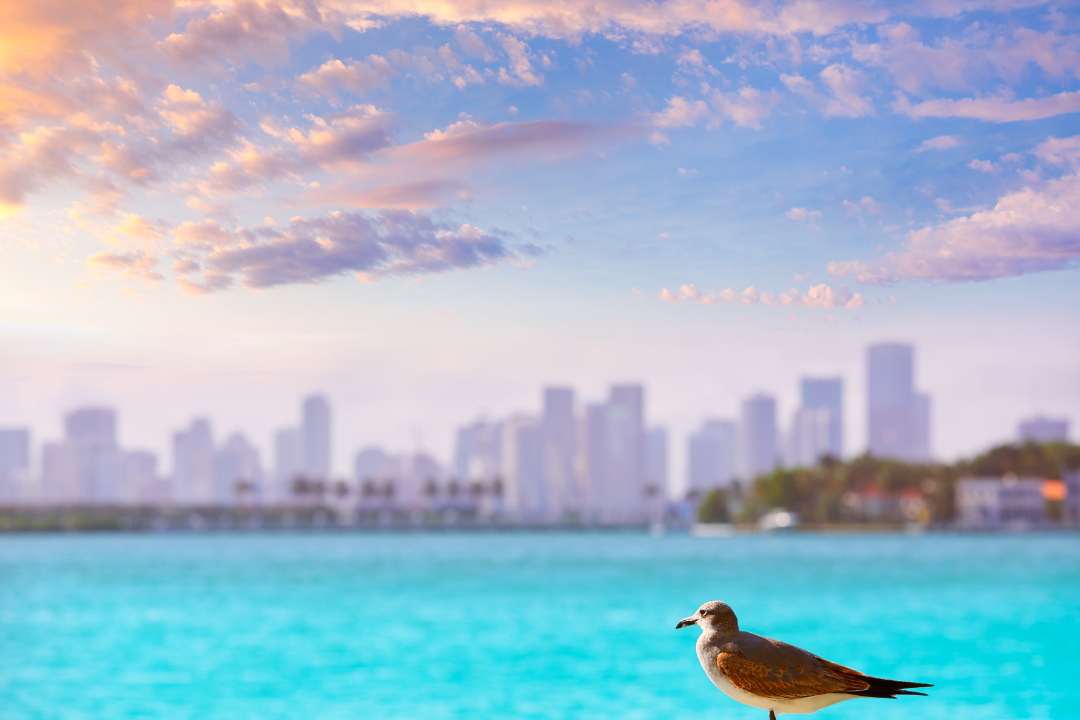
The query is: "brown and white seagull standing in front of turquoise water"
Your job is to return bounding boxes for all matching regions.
[675,601,933,720]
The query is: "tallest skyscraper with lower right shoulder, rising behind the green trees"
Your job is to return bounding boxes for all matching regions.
[867,342,931,462]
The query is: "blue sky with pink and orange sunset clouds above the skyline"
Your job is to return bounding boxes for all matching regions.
[0,0,1080,483]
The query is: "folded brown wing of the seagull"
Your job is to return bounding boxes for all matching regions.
[716,651,869,698]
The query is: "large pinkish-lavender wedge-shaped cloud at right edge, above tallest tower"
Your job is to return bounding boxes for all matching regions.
[828,136,1080,284]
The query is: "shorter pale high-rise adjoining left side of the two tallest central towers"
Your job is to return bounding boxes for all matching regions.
[500,416,551,520]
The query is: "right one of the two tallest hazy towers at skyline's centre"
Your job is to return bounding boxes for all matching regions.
[604,385,649,522]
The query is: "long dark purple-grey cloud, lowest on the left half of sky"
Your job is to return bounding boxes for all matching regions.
[175,210,514,293]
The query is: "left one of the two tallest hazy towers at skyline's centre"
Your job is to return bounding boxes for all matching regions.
[540,388,584,517]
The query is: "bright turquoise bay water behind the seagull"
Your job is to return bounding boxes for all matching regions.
[0,534,1080,720]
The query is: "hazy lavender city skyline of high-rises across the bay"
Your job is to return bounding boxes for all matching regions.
[0,343,1069,507]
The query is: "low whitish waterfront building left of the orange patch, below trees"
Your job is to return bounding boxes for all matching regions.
[956,473,1047,530]
